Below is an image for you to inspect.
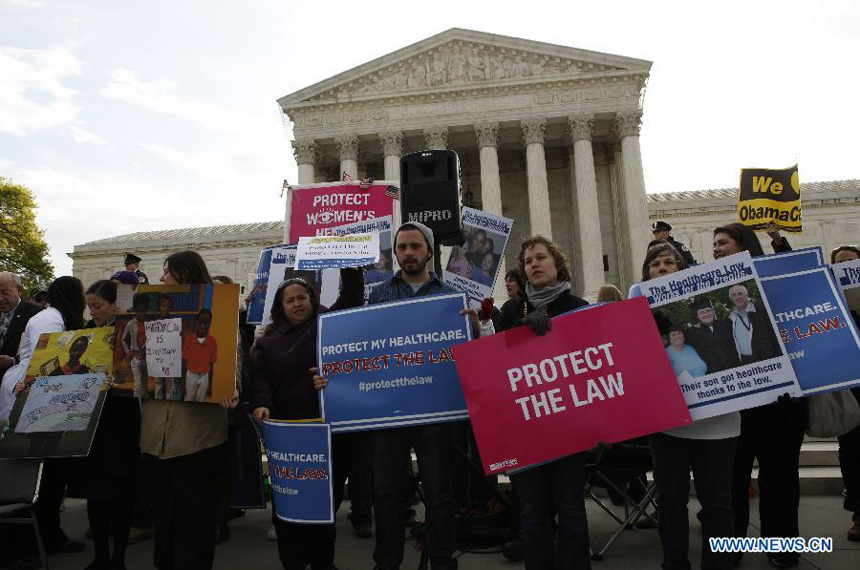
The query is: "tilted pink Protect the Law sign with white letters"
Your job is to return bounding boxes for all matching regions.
[454,298,692,473]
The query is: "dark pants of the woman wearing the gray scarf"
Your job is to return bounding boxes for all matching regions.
[513,453,591,570]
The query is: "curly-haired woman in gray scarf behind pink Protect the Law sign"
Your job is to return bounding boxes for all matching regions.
[501,236,591,570]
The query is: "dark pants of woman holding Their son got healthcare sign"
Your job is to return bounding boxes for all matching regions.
[650,433,737,570]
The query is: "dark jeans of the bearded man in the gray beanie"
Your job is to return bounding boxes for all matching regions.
[373,424,457,570]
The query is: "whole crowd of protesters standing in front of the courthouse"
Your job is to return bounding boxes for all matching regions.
[0,214,860,570]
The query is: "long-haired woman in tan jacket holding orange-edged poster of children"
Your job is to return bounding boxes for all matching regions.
[140,251,238,570]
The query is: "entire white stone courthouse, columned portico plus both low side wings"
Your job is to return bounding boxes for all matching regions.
[69,29,860,298]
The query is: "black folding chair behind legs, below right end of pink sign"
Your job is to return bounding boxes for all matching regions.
[585,439,657,561]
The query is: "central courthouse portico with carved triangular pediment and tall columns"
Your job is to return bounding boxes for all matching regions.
[278,29,651,296]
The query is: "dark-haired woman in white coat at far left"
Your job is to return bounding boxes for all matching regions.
[0,276,86,564]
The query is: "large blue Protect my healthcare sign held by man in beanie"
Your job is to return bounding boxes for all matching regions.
[317,293,472,432]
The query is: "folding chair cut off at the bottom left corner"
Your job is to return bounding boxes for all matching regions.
[0,459,48,570]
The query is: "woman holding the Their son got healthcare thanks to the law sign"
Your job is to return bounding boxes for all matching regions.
[637,240,754,568]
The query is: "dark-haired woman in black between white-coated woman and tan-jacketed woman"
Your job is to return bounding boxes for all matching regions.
[80,280,140,570]
